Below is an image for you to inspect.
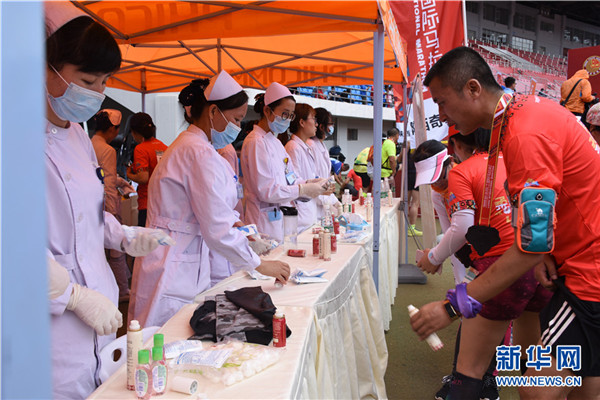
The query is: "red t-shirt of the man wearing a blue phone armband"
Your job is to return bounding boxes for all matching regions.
[502,95,600,302]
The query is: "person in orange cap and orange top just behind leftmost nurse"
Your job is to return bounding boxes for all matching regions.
[92,109,135,302]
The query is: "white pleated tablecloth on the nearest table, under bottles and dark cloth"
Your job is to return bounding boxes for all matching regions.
[91,201,398,399]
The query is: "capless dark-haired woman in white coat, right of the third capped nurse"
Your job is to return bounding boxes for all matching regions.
[285,103,318,232]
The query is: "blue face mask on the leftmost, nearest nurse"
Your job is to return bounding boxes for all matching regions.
[46,67,105,122]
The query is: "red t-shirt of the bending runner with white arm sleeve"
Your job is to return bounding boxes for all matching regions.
[447,153,515,260]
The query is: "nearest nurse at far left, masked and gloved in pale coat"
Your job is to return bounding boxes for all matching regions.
[44,2,158,399]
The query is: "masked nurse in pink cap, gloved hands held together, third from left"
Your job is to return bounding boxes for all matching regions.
[241,82,328,242]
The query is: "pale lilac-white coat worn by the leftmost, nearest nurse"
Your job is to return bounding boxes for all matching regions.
[46,122,124,399]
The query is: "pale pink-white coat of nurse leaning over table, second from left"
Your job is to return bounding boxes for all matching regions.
[128,125,260,326]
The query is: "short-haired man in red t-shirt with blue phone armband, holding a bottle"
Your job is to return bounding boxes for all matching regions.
[411,47,600,400]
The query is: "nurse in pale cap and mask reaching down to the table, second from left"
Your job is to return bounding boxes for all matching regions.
[129,71,290,326]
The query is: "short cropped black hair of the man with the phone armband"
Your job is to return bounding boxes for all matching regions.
[423,47,502,92]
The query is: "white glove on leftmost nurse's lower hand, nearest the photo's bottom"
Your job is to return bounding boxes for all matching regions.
[67,283,123,336]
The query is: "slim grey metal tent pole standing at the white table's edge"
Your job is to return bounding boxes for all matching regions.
[372,22,384,293]
